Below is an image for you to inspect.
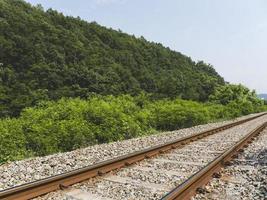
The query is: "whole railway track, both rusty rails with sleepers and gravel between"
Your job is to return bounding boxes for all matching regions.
[0,113,267,200]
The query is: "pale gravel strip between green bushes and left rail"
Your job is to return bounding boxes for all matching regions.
[0,112,264,190]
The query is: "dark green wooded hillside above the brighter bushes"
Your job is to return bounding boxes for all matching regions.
[0,0,224,117]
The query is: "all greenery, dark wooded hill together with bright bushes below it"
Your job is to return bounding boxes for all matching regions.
[0,0,266,163]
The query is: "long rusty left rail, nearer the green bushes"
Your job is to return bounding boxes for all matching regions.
[0,113,267,200]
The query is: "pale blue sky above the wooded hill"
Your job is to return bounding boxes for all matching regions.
[26,0,267,93]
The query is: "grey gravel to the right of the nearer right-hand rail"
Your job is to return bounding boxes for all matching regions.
[194,125,267,200]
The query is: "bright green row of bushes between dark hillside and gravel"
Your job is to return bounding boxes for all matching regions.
[0,90,266,163]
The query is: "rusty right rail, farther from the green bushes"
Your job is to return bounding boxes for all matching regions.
[162,122,267,200]
